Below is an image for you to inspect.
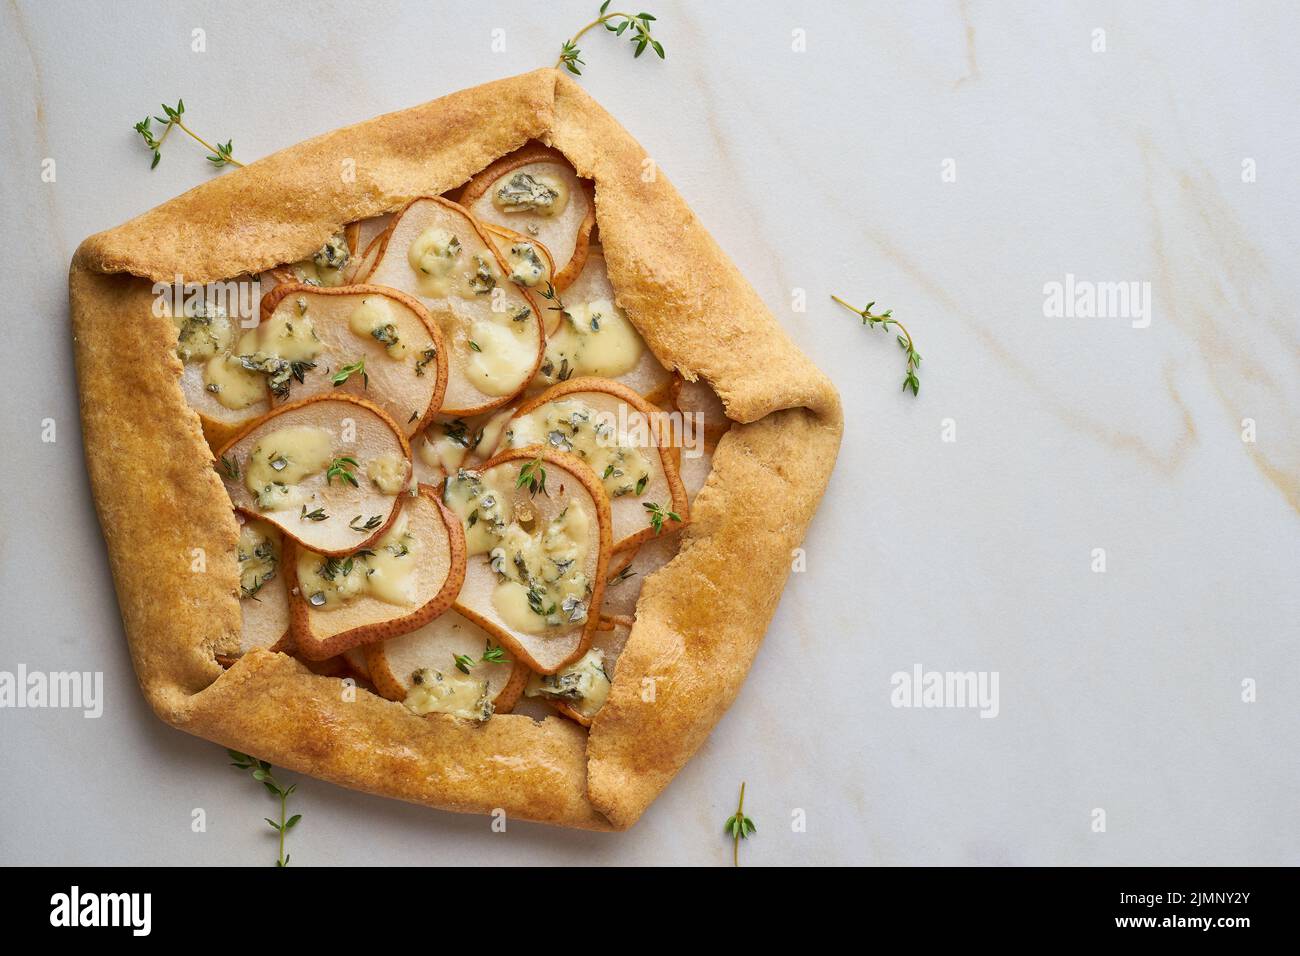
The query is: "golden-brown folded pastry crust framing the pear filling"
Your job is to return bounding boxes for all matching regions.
[70,69,842,829]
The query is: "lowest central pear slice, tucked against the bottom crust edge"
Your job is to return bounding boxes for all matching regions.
[365,610,529,719]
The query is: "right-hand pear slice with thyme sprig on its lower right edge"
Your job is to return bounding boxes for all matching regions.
[501,378,688,551]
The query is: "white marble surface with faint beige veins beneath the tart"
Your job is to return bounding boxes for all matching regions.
[0,0,1300,865]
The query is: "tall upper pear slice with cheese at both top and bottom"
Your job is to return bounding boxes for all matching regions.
[365,198,545,415]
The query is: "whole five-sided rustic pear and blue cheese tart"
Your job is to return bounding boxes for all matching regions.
[70,70,841,829]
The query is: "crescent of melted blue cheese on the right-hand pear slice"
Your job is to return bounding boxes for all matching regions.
[503,398,650,498]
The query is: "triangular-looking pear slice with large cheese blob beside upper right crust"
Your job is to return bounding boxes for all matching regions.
[530,246,675,403]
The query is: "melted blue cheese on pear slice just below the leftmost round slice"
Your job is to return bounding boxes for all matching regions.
[298,512,424,609]
